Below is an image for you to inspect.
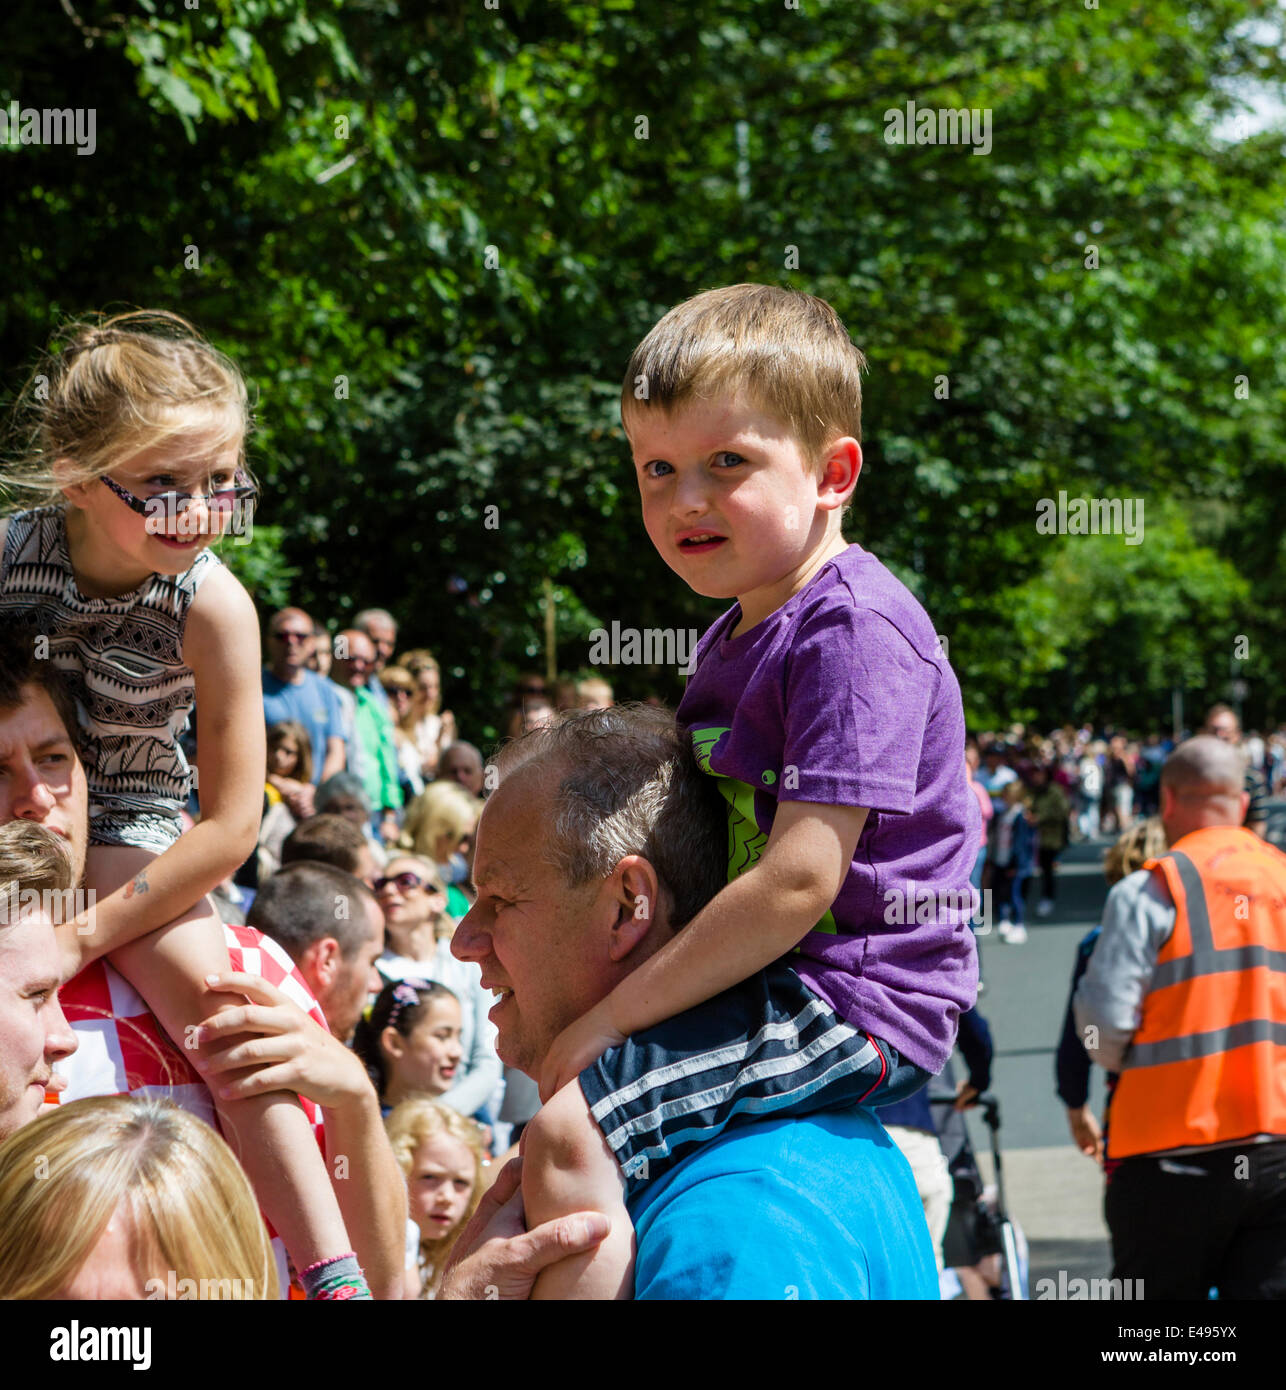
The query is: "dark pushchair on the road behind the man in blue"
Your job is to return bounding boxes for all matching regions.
[929,1083,1029,1301]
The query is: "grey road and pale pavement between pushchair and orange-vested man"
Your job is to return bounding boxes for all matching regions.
[957,840,1111,1297]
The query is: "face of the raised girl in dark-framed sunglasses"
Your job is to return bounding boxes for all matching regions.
[65,432,241,574]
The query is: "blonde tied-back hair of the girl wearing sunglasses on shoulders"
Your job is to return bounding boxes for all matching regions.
[4,309,252,506]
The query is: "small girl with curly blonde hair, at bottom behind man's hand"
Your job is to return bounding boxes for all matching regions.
[385,1098,485,1298]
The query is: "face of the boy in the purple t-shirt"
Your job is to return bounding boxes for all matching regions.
[626,399,861,621]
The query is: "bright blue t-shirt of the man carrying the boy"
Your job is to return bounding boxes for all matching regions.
[630,1106,938,1300]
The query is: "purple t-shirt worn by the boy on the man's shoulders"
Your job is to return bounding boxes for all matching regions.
[678,545,982,1072]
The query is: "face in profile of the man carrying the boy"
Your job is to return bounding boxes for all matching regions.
[450,765,620,1076]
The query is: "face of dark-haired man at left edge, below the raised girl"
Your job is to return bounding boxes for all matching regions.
[0,685,89,883]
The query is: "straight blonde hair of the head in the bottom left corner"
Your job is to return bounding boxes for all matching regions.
[0,1095,278,1300]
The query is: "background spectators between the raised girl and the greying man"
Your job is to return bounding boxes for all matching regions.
[190,607,631,1297]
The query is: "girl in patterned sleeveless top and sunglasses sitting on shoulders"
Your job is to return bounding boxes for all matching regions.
[0,311,370,1298]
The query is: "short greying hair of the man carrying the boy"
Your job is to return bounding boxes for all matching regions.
[495,705,729,929]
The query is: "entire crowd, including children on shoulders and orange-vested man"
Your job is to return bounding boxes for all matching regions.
[0,296,1286,1301]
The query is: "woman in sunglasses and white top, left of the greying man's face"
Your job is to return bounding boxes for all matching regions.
[375,853,502,1123]
